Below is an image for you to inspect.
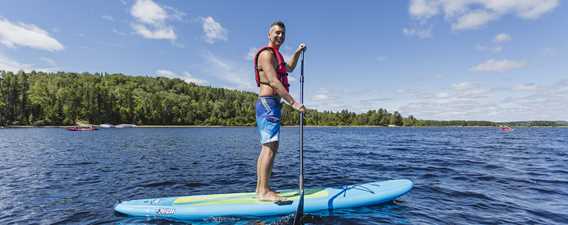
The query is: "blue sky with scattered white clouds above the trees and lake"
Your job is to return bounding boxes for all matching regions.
[0,0,568,121]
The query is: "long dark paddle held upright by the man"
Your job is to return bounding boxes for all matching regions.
[294,49,305,225]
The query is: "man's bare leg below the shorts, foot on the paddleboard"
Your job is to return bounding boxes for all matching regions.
[256,141,286,201]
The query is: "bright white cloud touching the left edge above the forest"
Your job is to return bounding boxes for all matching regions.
[0,18,63,51]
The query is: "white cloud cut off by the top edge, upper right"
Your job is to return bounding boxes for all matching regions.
[409,0,559,30]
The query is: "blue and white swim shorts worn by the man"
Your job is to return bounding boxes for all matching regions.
[256,96,282,144]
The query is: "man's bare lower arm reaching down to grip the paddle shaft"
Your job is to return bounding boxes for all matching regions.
[258,51,305,112]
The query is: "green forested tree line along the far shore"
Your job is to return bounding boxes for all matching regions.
[0,71,560,126]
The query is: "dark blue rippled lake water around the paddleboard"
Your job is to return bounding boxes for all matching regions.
[0,128,568,224]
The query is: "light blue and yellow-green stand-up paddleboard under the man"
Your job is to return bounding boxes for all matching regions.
[114,180,413,220]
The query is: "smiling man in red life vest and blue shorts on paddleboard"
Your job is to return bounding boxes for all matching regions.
[254,21,306,201]
